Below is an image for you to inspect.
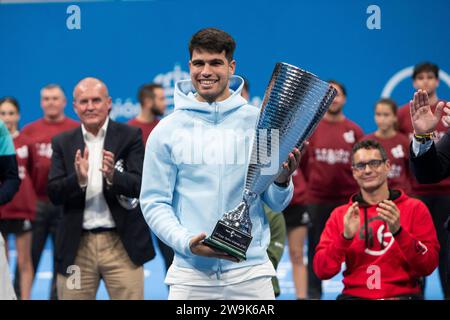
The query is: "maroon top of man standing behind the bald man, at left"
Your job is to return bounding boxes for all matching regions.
[22,118,80,201]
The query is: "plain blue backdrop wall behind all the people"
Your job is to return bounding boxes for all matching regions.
[0,0,450,132]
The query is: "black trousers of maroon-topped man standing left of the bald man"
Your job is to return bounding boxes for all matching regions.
[14,201,62,300]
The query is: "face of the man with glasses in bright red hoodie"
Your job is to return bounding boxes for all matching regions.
[352,148,391,193]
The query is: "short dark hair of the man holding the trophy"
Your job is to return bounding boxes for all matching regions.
[189,28,236,61]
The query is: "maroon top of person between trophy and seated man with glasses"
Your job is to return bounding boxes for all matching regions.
[300,119,364,204]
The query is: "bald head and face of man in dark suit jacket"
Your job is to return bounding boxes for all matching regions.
[73,78,112,132]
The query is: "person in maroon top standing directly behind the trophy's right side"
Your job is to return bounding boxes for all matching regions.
[301,80,364,299]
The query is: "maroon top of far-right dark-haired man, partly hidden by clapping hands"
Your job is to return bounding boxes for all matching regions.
[397,103,450,196]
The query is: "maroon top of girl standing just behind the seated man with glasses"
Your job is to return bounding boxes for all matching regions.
[361,132,411,194]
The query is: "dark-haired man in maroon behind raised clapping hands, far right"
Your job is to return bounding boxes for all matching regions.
[398,62,450,299]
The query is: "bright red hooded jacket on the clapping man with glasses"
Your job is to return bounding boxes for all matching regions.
[313,190,439,299]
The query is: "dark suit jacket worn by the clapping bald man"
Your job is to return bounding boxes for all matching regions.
[47,120,155,274]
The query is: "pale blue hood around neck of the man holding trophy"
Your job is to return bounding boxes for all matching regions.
[174,76,248,122]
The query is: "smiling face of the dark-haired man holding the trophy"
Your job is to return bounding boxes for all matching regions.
[189,49,236,103]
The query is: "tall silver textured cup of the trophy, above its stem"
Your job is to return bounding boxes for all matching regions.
[245,62,336,194]
